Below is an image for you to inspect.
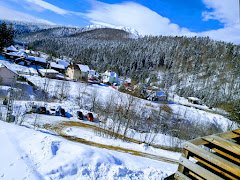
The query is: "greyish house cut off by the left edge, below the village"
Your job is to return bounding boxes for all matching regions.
[0,63,18,86]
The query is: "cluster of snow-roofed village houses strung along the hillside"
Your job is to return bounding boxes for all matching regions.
[2,44,172,102]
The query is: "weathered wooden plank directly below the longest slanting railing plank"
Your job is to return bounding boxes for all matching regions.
[180,157,222,180]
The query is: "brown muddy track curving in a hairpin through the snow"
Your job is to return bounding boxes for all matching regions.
[44,122,178,164]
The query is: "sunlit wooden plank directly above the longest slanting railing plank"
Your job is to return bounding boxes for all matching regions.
[203,135,240,156]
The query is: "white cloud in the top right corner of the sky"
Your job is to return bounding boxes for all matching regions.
[202,0,239,26]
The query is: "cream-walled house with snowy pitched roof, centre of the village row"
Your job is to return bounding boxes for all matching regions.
[66,64,90,81]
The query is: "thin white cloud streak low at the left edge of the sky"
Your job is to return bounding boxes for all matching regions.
[0,6,54,25]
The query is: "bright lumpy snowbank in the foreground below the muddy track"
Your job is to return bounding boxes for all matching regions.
[0,121,177,180]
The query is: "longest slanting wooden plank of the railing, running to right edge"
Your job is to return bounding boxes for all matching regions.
[184,142,240,177]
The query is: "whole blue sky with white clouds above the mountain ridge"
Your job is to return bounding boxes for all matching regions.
[0,0,240,44]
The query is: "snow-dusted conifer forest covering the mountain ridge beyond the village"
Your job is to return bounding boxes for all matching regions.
[17,27,240,105]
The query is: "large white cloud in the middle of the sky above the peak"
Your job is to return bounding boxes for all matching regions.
[85,1,191,35]
